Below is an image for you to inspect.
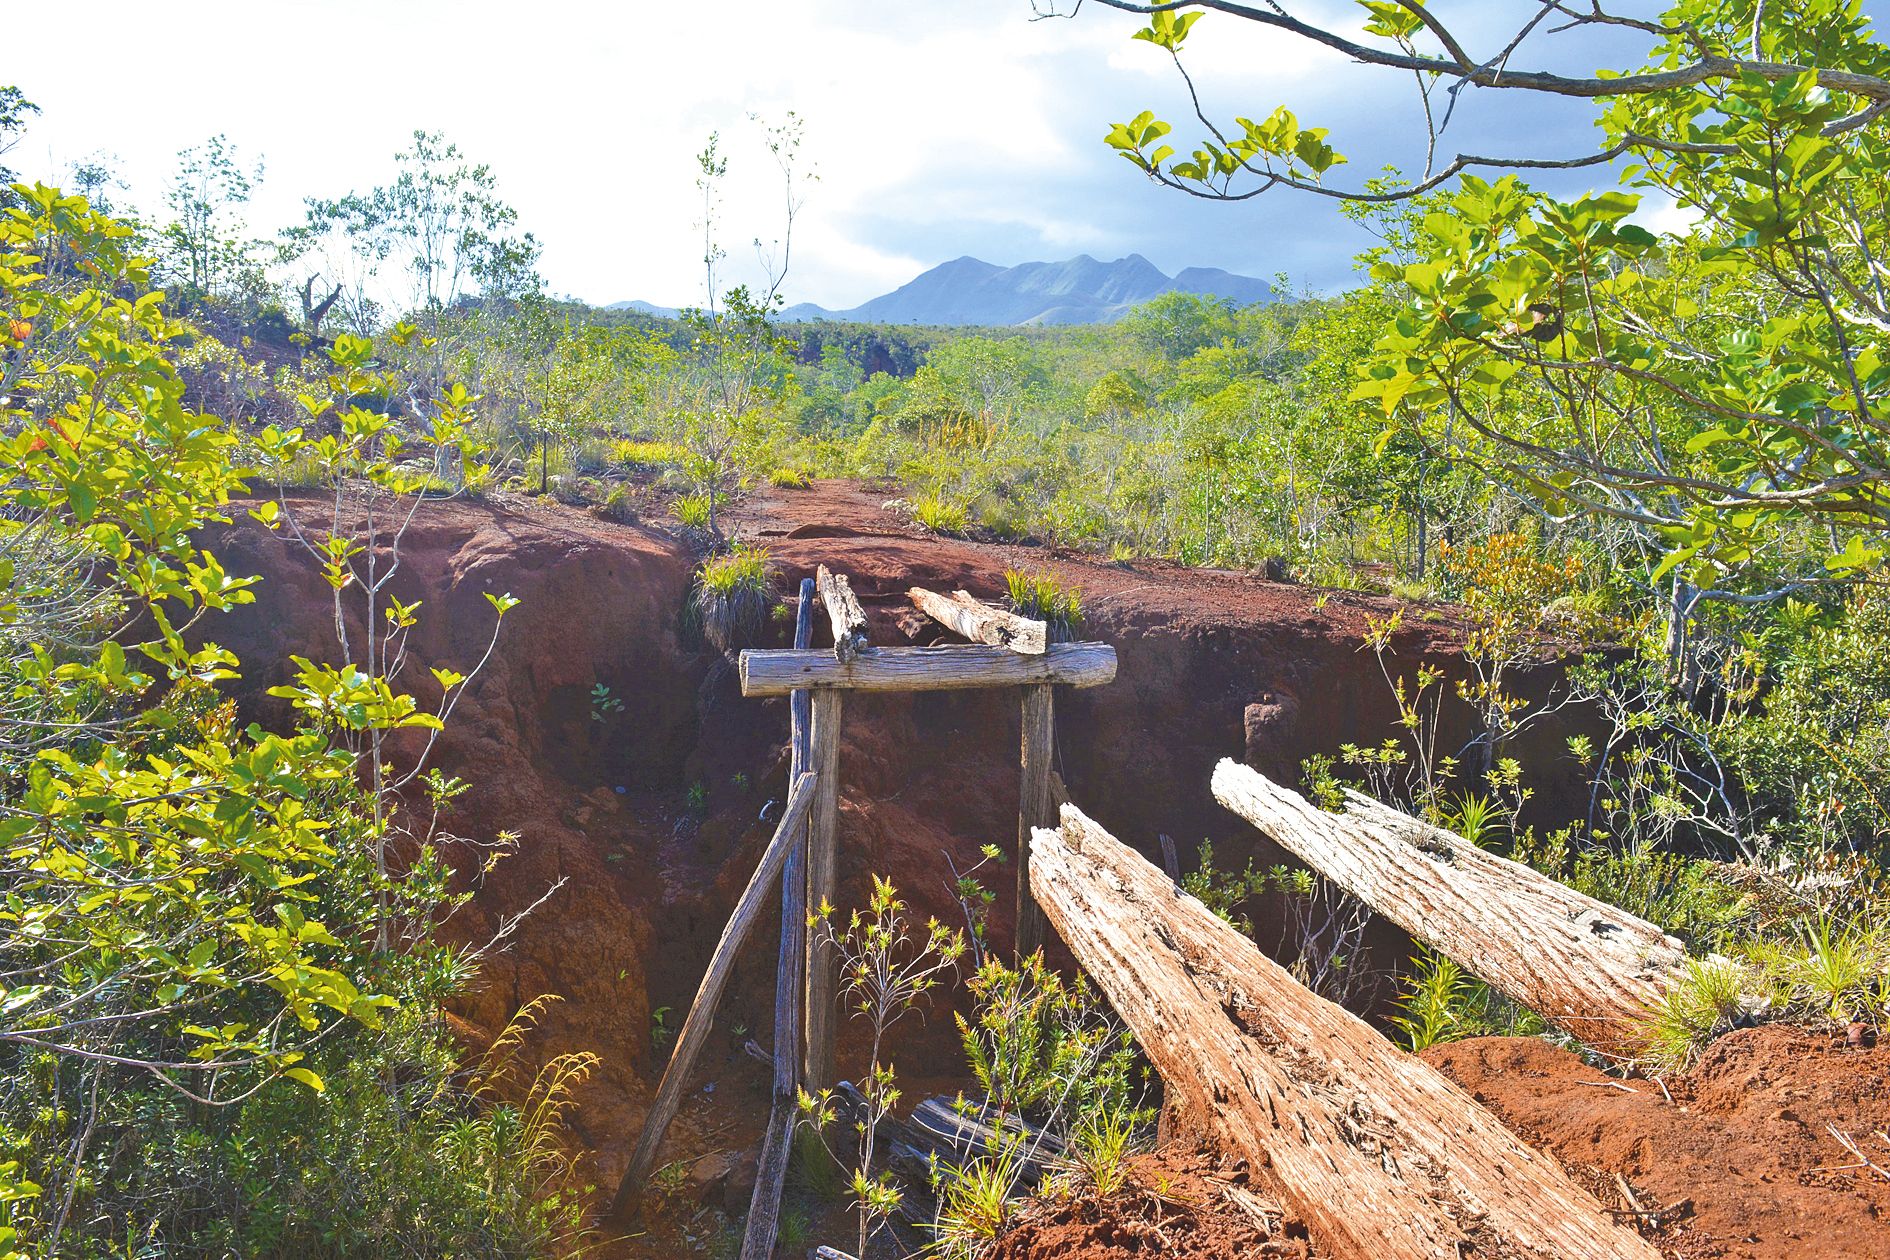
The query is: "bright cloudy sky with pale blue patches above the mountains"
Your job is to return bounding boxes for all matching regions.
[11,0,1716,310]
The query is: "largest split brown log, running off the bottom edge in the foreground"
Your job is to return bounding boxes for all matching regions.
[1030,805,1658,1260]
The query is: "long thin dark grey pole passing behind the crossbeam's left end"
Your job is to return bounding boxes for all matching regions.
[741,578,816,1260]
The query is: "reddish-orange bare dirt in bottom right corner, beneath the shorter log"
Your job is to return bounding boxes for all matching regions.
[1423,1026,1890,1260]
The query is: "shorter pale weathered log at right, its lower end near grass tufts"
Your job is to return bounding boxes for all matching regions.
[1213,761,1686,1056]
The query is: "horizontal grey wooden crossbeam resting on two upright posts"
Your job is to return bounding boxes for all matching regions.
[739,642,1115,695]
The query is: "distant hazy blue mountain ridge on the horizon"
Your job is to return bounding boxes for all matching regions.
[607,253,1274,327]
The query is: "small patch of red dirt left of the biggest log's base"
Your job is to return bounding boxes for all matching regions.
[987,1152,1319,1260]
